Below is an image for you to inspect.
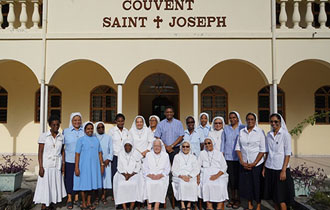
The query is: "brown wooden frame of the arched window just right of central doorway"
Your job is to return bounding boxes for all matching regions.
[200,85,229,122]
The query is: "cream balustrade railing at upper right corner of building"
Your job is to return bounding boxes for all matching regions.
[276,0,330,31]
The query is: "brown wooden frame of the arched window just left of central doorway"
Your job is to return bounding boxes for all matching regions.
[89,85,118,124]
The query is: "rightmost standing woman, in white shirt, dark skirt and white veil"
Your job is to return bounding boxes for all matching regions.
[262,113,294,210]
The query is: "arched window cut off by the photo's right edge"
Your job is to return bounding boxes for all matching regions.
[314,86,330,124]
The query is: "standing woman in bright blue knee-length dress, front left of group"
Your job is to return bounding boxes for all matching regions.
[73,122,104,209]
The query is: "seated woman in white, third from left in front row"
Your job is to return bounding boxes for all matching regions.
[172,140,200,210]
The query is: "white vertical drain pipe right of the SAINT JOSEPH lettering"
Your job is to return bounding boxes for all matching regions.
[270,0,277,113]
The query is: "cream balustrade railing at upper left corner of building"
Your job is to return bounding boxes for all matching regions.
[0,0,42,32]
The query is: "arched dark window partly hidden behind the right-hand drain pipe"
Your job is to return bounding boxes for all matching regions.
[258,86,285,123]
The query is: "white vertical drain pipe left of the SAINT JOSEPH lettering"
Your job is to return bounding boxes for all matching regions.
[40,0,48,133]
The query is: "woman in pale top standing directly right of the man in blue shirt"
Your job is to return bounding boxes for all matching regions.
[183,116,204,157]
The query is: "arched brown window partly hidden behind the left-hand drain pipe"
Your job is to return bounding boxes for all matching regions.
[35,86,62,122]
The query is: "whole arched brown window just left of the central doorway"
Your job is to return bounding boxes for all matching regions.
[90,85,117,123]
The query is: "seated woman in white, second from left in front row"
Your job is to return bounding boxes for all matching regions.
[143,139,171,210]
